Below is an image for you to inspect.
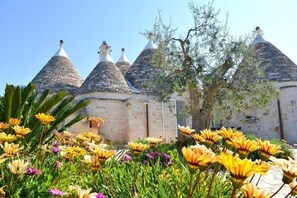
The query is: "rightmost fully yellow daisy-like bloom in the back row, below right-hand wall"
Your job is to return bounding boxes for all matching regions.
[258,139,283,161]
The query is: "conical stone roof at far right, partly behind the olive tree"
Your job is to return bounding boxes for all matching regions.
[251,27,297,81]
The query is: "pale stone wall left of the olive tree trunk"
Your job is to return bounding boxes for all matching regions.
[69,92,186,143]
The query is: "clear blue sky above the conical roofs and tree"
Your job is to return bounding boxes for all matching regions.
[0,0,297,95]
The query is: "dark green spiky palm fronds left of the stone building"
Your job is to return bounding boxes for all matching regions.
[0,83,88,150]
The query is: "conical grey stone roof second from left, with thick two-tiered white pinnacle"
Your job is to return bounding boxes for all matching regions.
[79,42,131,93]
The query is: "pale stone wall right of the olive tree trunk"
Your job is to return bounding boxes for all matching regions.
[216,82,297,143]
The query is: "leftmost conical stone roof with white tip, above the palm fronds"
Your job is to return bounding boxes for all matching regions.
[32,40,83,94]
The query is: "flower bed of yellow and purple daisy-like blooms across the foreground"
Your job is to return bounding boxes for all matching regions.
[0,114,297,198]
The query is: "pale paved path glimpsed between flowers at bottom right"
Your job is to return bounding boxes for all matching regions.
[253,149,297,198]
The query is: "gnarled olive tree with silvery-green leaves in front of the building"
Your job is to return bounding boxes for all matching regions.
[143,2,276,131]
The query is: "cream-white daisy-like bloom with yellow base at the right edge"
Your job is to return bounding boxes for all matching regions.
[269,156,297,184]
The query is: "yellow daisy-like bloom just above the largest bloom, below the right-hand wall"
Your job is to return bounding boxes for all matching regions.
[231,137,260,159]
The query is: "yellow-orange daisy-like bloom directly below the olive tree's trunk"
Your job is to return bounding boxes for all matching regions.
[193,129,222,148]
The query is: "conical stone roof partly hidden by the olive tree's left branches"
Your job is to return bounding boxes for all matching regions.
[125,35,161,92]
